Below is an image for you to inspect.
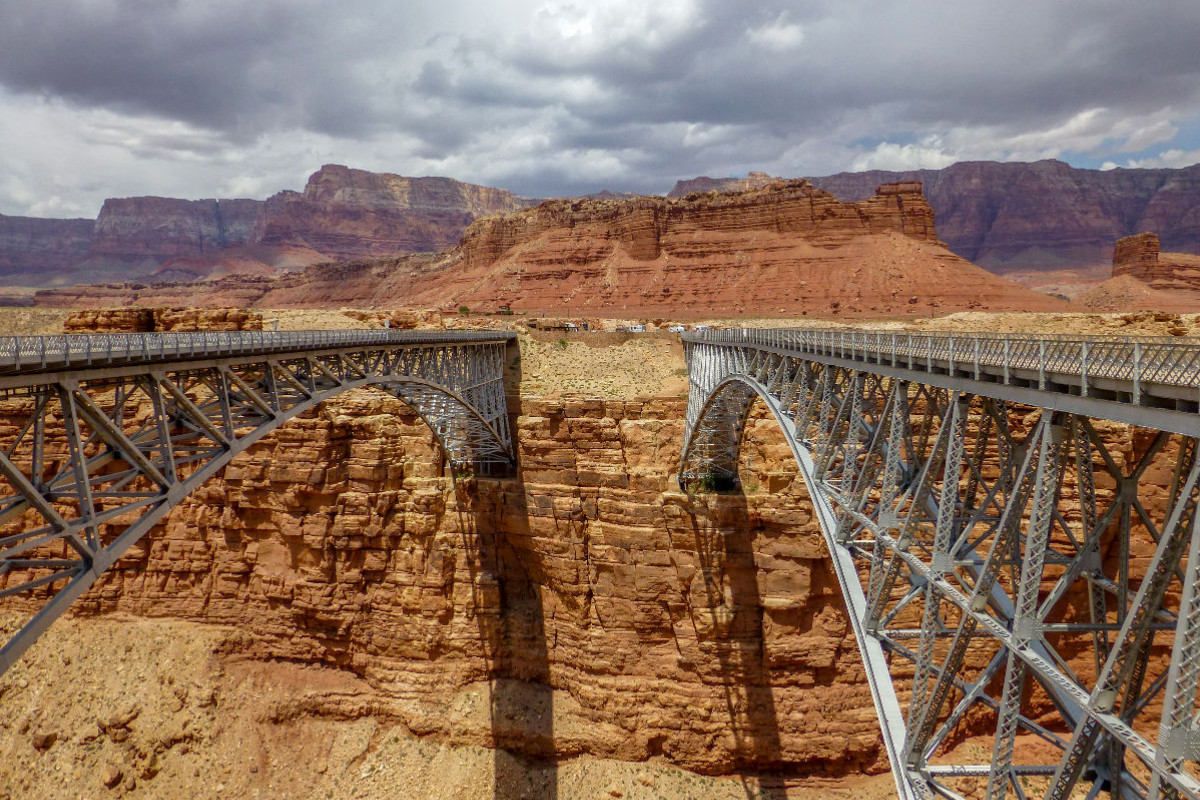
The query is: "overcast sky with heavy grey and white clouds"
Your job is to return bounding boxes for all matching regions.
[0,0,1200,217]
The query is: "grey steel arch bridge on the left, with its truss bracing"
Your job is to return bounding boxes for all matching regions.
[0,330,515,672]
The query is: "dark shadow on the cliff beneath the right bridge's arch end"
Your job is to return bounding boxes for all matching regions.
[682,488,787,800]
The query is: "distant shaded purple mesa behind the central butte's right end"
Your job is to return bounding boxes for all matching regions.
[812,161,1200,271]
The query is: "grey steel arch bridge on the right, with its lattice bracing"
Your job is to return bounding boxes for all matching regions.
[680,331,1200,799]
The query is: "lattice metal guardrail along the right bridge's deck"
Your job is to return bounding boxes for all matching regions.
[683,329,1200,403]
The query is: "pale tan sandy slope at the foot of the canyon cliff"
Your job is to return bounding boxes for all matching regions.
[0,616,894,800]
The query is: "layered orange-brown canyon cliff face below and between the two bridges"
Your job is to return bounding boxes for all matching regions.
[32,392,886,775]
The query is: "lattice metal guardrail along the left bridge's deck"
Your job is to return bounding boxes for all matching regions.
[0,329,516,374]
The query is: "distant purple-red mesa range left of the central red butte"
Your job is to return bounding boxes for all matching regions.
[0,164,532,287]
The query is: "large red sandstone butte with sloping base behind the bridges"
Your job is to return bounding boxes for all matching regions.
[37,180,1069,317]
